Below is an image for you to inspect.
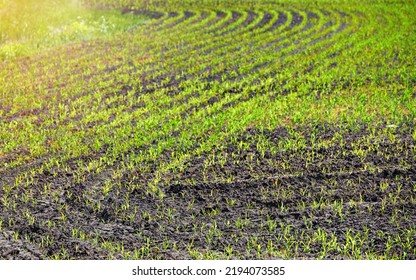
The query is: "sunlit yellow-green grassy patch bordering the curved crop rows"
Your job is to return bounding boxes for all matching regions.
[0,0,150,60]
